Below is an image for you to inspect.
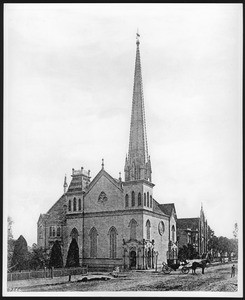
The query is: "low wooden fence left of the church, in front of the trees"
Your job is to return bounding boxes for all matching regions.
[7,266,88,281]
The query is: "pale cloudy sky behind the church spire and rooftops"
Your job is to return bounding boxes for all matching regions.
[3,3,243,246]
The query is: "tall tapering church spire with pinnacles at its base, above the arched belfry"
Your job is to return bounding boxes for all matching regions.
[124,33,151,182]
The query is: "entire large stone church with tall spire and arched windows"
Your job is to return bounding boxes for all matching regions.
[37,35,177,270]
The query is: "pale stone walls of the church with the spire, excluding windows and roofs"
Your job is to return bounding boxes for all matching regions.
[38,169,177,269]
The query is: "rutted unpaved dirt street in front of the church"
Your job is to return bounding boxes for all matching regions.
[9,264,237,292]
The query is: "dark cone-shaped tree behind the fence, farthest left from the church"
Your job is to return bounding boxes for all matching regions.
[11,235,29,271]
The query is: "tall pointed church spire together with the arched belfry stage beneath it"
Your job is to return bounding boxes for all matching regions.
[123,33,154,211]
